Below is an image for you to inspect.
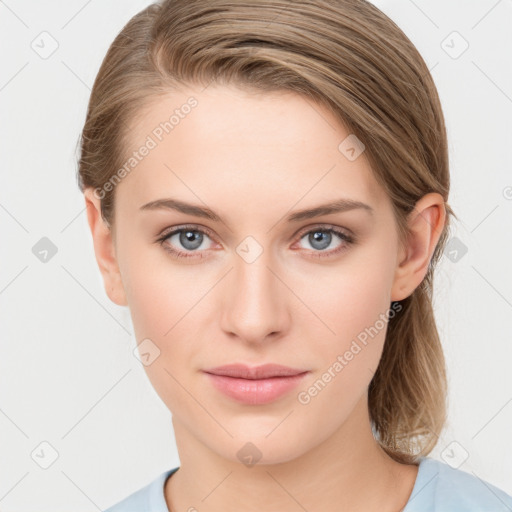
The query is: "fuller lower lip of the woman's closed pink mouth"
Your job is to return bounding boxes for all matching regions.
[205,372,309,405]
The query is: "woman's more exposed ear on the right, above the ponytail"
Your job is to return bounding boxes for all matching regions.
[391,192,446,301]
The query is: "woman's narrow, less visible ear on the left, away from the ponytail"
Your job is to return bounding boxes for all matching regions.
[84,188,128,306]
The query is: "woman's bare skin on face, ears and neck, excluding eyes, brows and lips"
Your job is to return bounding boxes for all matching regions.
[85,85,446,512]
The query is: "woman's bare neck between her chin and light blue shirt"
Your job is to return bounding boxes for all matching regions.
[165,395,417,512]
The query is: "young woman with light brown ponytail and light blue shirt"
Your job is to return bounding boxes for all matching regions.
[79,0,512,512]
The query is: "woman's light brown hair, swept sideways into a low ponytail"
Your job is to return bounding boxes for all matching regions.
[78,0,456,463]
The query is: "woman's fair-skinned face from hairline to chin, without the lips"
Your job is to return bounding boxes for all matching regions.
[107,86,402,463]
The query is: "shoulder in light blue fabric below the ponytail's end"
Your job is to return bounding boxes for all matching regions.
[403,457,512,512]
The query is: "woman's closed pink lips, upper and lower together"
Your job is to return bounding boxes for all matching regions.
[204,364,309,405]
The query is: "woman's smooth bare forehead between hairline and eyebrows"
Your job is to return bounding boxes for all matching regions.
[118,85,387,213]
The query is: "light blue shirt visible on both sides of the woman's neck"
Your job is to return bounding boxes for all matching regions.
[105,457,512,512]
